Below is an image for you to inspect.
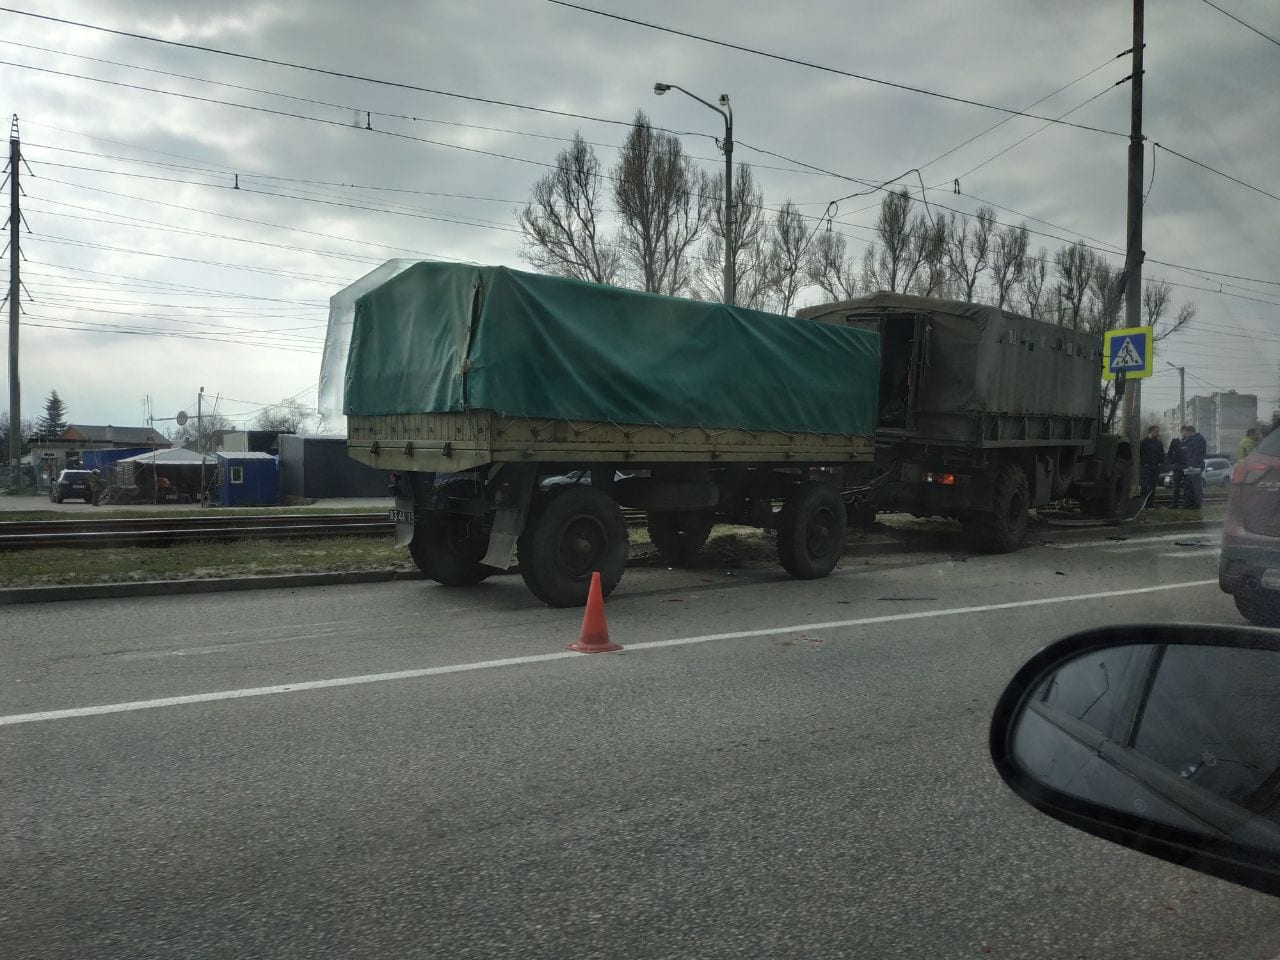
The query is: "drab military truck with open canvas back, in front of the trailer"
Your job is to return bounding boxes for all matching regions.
[797,293,1134,552]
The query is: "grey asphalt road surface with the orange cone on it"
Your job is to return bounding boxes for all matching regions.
[0,534,1280,960]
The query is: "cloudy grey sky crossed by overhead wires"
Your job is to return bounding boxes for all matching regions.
[0,0,1280,425]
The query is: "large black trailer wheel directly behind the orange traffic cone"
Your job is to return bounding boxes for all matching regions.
[517,485,627,607]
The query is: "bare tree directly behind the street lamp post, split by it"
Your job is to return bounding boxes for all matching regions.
[694,164,773,307]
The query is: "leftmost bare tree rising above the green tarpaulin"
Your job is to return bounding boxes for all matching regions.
[516,133,621,283]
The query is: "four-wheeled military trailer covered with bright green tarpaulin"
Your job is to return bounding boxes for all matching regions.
[332,262,879,607]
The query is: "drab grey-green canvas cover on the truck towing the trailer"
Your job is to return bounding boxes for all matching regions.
[800,293,1102,442]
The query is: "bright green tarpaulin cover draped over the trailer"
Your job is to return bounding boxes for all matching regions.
[343,262,879,435]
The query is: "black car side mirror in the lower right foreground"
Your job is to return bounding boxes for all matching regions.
[991,625,1280,895]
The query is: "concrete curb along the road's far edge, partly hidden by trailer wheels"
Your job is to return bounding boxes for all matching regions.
[0,520,1221,607]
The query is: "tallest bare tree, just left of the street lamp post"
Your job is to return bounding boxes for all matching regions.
[613,110,709,294]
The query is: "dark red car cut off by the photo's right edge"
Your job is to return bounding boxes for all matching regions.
[1217,429,1280,627]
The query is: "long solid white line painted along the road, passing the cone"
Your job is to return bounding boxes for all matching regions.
[0,580,1217,727]
